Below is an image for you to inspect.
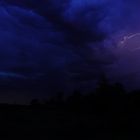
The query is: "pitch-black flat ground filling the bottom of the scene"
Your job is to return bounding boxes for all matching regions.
[0,94,140,140]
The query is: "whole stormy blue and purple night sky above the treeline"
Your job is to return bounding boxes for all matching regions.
[0,0,140,102]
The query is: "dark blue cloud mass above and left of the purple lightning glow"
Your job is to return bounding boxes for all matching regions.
[0,0,140,101]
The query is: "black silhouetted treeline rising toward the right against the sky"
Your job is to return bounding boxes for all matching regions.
[30,81,140,114]
